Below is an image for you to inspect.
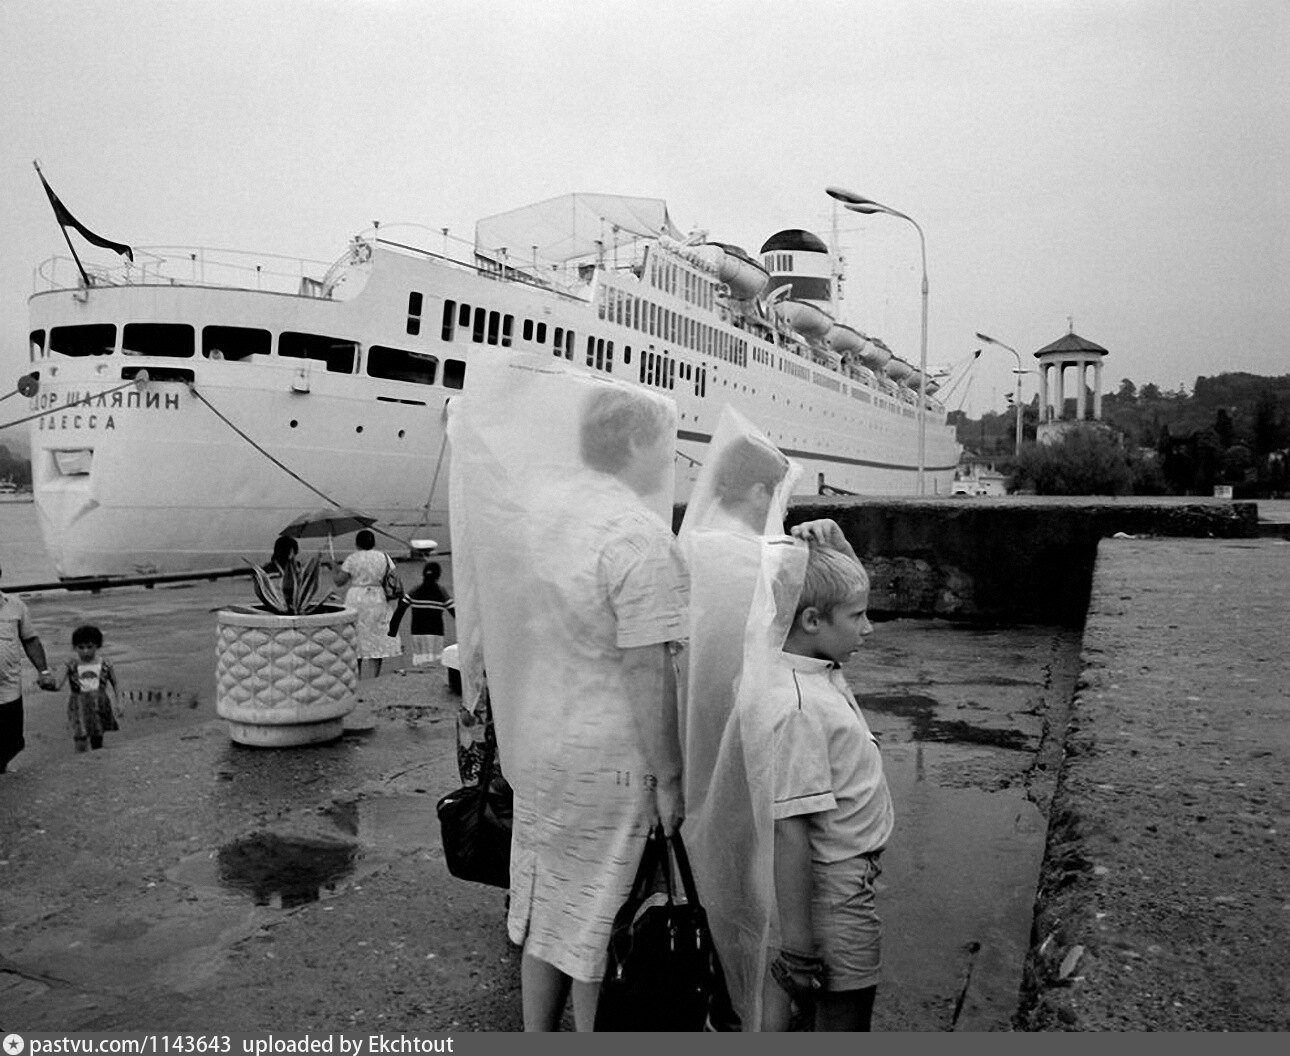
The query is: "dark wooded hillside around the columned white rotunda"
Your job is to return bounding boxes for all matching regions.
[949,373,1290,498]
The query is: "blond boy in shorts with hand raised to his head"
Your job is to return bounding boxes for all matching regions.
[762,521,894,1030]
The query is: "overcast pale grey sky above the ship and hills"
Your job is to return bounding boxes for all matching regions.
[0,0,1290,441]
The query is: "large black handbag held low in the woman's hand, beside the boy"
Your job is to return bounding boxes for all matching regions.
[595,825,739,1030]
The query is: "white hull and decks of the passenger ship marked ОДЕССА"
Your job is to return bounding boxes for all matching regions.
[28,194,958,578]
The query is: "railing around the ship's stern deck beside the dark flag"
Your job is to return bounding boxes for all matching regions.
[32,246,332,297]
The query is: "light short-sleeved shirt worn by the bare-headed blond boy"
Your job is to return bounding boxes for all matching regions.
[768,652,895,863]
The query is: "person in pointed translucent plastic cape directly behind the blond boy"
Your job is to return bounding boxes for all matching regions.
[680,407,806,1030]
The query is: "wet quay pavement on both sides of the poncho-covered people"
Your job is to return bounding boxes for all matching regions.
[0,582,1080,1032]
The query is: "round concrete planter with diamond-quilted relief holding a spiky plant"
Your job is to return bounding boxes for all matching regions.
[215,606,359,748]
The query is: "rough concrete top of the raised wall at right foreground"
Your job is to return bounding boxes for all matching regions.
[1027,539,1290,1030]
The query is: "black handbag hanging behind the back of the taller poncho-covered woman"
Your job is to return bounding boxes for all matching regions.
[435,738,515,887]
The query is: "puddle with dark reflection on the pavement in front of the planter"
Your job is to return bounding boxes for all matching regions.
[166,794,439,909]
